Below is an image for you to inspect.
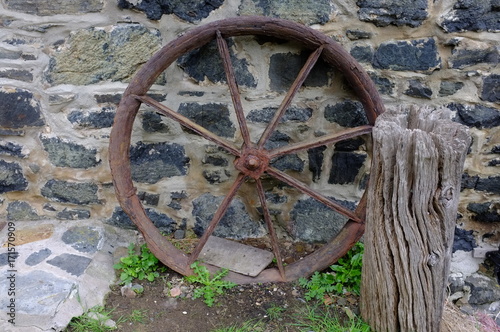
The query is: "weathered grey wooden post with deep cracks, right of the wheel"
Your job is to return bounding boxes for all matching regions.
[360,106,470,332]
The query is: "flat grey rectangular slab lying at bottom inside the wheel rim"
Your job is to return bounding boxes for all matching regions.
[199,236,274,277]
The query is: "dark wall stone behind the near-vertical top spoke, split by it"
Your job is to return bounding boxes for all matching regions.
[177,39,257,87]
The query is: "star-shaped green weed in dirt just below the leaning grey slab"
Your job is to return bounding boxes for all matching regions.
[185,262,236,307]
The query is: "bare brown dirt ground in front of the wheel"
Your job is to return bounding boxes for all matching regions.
[98,272,358,332]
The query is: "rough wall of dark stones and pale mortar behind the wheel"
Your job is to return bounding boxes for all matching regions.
[0,0,500,292]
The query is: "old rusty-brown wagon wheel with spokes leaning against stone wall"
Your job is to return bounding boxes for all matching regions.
[109,16,384,283]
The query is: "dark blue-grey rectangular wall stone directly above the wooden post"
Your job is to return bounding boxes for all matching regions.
[373,38,441,73]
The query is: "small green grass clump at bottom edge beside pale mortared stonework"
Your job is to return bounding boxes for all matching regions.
[68,306,121,332]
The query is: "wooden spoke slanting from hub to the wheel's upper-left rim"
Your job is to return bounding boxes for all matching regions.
[134,95,240,156]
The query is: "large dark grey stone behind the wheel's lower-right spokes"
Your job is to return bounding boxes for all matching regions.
[290,198,354,243]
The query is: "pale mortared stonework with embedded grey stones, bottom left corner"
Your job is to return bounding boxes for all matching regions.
[0,219,137,332]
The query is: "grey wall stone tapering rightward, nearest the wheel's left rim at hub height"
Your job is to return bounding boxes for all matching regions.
[40,136,101,168]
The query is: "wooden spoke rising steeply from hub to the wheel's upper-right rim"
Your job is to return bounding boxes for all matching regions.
[258,45,323,148]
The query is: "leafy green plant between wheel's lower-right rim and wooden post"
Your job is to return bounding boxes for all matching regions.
[299,242,364,301]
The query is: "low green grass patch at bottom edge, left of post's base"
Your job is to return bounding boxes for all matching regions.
[293,306,370,332]
